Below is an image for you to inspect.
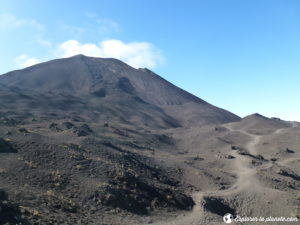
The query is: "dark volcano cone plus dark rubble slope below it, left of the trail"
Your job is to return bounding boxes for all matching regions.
[0,55,240,225]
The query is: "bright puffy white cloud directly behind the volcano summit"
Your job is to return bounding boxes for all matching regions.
[58,40,164,68]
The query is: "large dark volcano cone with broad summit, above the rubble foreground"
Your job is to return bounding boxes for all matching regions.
[0,55,239,128]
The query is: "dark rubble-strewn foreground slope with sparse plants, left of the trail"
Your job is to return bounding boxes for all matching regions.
[0,118,194,224]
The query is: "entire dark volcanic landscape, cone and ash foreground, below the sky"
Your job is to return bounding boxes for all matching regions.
[0,55,300,225]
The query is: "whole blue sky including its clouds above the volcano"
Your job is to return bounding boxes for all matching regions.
[0,0,300,121]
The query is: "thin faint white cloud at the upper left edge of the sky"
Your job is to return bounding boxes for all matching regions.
[0,13,44,30]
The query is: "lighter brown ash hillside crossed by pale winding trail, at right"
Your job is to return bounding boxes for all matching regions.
[153,114,300,225]
